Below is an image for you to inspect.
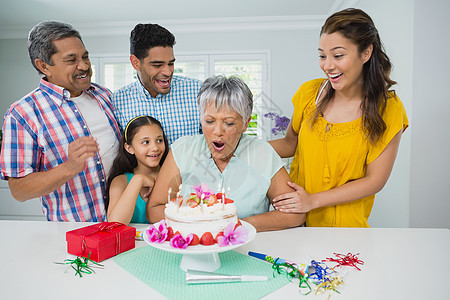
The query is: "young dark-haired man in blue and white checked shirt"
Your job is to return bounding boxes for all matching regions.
[113,24,201,144]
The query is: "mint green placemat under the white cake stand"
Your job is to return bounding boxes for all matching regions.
[114,246,289,300]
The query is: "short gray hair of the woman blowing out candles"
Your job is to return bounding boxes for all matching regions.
[197,75,253,124]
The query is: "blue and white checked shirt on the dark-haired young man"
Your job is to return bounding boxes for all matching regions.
[113,75,202,144]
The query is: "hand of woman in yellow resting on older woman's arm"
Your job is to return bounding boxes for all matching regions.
[272,181,316,213]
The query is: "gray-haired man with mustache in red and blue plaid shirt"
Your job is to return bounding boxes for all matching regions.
[0,21,120,222]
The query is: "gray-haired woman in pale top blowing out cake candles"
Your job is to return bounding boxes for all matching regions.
[147,76,305,231]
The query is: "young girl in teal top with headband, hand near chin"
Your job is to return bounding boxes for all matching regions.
[106,116,169,224]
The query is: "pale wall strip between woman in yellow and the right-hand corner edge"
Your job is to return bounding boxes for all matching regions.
[358,0,414,227]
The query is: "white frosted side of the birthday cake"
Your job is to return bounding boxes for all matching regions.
[164,201,238,238]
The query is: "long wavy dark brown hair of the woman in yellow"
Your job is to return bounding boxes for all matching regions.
[312,8,396,143]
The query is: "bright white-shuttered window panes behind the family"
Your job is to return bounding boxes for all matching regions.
[91,52,269,138]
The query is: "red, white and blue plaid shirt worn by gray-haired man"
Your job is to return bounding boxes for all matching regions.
[0,78,120,222]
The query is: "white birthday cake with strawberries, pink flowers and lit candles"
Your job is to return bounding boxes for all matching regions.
[146,184,248,249]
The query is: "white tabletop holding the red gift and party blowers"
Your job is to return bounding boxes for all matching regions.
[0,221,450,300]
